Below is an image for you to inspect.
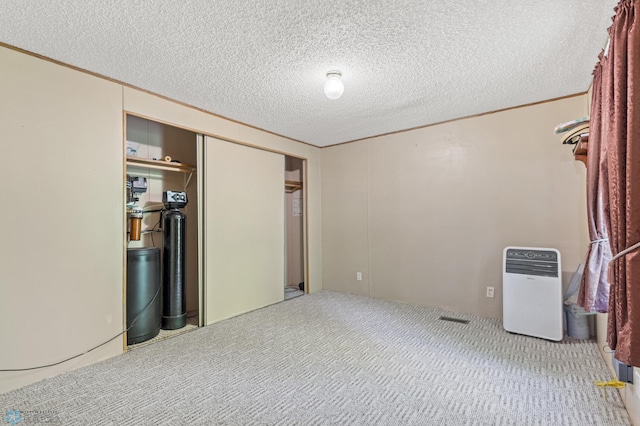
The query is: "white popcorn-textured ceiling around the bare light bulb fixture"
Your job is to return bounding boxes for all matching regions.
[0,0,617,146]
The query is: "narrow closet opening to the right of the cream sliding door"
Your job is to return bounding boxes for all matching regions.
[284,156,308,300]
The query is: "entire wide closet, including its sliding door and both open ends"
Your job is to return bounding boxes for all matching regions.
[124,114,308,349]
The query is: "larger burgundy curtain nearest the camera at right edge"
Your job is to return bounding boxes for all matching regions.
[601,0,640,366]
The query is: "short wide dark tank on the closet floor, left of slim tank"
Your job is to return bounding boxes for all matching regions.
[127,247,162,345]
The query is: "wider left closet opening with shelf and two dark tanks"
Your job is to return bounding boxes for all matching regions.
[124,114,202,350]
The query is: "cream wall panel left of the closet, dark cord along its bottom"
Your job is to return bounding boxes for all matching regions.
[0,47,124,392]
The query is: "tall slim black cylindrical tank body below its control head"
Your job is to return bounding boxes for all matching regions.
[162,209,187,330]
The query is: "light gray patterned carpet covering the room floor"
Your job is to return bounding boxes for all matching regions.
[0,292,629,426]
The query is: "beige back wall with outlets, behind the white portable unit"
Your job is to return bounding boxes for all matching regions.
[322,96,588,318]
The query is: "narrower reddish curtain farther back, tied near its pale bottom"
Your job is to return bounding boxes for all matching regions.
[578,54,611,312]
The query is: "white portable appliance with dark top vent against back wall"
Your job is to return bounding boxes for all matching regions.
[502,247,563,341]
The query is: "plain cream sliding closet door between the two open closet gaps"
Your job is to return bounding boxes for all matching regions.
[204,137,285,324]
